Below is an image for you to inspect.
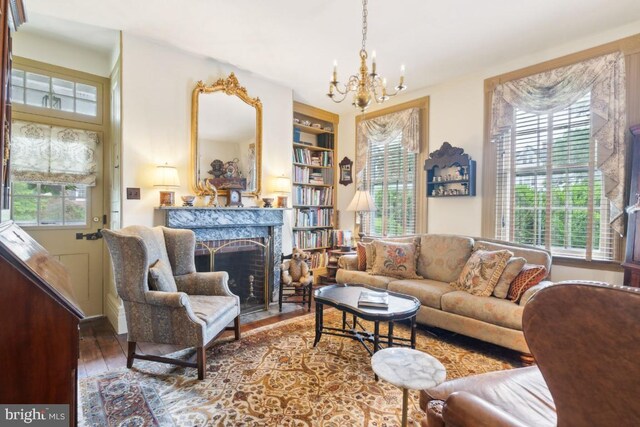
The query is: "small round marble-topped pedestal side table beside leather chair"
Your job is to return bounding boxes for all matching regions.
[371,347,447,427]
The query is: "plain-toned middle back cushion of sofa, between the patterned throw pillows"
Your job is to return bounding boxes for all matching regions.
[416,234,473,283]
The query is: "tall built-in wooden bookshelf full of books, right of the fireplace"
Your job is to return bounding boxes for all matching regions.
[291,102,338,282]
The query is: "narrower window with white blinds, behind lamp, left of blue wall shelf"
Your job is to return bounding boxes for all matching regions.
[362,134,417,236]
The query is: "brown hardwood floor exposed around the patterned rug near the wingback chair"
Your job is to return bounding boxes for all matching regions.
[78,304,313,378]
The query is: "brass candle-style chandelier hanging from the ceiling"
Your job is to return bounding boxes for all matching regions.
[327,0,407,112]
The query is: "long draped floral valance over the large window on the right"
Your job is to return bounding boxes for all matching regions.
[491,52,626,235]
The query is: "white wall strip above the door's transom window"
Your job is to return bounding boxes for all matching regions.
[13,31,112,78]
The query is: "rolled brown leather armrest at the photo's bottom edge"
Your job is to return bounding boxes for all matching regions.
[442,391,526,427]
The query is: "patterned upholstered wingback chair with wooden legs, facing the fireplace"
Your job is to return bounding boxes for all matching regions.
[103,226,240,379]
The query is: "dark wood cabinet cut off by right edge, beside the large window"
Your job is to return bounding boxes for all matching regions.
[622,124,640,287]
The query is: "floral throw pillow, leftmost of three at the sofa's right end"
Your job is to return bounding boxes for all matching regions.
[451,250,513,297]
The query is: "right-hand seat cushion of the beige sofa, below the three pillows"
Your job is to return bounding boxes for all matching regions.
[440,291,524,331]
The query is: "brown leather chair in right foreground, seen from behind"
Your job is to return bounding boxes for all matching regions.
[420,282,640,427]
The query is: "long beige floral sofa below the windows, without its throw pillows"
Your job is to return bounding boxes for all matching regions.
[336,234,551,355]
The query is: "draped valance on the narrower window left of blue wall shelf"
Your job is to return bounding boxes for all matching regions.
[356,108,420,179]
